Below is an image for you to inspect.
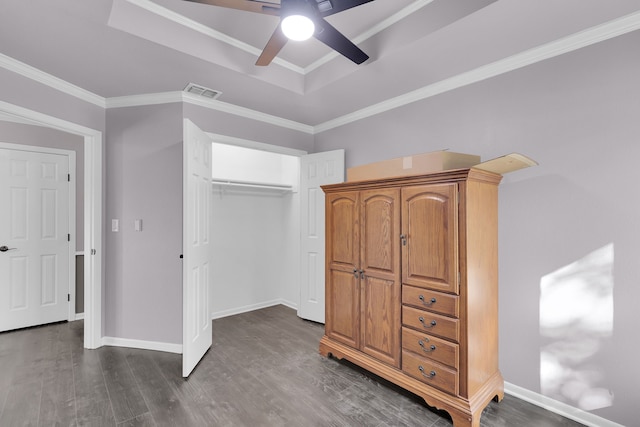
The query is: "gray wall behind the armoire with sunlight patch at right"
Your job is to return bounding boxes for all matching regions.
[315,31,640,425]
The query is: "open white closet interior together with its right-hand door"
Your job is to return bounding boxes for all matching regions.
[210,142,344,322]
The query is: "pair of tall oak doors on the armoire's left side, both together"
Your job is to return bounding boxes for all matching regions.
[325,189,401,368]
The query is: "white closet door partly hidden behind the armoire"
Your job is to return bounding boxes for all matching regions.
[298,150,344,323]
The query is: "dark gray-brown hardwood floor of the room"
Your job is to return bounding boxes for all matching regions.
[0,306,581,427]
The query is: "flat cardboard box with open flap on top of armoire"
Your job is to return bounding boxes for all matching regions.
[347,150,537,182]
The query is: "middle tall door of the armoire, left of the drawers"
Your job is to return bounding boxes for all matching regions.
[360,188,401,367]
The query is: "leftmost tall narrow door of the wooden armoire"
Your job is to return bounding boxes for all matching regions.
[325,192,360,348]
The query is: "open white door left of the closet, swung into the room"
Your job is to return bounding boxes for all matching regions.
[182,119,213,377]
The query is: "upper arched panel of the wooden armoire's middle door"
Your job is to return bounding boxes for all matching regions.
[360,189,400,275]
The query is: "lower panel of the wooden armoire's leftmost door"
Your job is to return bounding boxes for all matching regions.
[325,270,360,348]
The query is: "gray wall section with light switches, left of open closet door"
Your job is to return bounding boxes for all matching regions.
[104,103,182,344]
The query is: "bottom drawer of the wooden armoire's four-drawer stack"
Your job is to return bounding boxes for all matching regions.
[402,350,458,395]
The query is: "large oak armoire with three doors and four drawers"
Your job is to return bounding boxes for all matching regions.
[320,169,504,427]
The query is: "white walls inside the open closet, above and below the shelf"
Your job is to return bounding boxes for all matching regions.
[211,144,299,318]
